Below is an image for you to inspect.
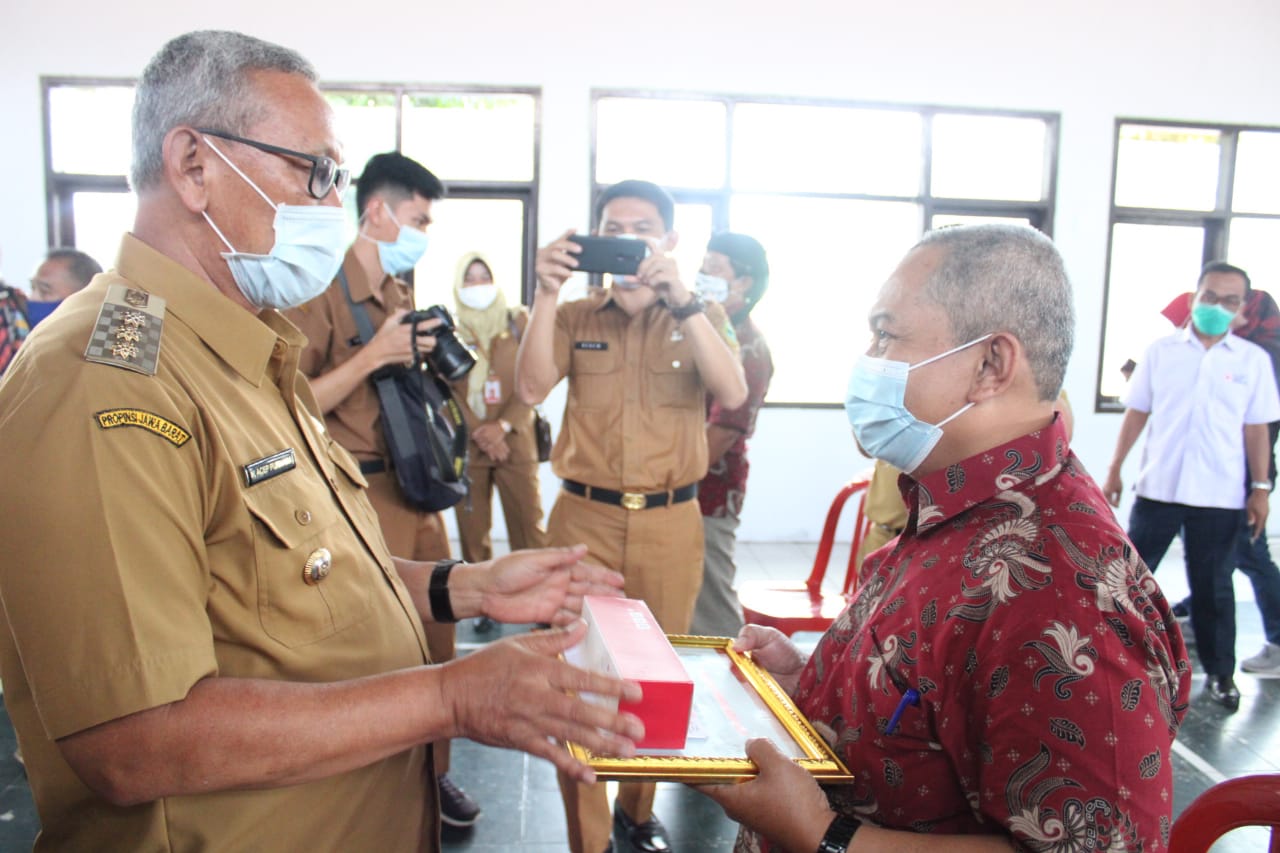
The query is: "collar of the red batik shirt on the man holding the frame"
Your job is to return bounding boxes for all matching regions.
[899,415,1071,533]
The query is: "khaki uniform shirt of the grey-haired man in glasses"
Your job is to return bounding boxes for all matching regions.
[0,236,435,850]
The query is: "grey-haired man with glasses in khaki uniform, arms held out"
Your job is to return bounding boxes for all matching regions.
[0,32,639,853]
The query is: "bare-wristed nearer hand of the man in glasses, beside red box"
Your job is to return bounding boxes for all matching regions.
[440,620,644,783]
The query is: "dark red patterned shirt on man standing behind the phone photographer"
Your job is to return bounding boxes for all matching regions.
[698,316,773,517]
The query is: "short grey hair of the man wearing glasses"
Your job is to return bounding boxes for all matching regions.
[129,29,317,191]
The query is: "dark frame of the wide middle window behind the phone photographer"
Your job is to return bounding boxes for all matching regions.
[588,87,1062,409]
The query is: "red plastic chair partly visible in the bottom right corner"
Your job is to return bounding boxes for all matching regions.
[1169,774,1280,853]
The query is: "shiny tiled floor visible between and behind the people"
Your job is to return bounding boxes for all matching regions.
[0,543,1280,853]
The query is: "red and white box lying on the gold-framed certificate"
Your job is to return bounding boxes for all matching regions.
[564,596,694,749]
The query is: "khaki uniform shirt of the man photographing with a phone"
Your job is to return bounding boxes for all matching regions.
[552,291,733,492]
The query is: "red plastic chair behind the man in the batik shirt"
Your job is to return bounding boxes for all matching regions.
[737,471,870,637]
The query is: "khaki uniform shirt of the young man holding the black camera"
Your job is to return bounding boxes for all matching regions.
[284,250,413,460]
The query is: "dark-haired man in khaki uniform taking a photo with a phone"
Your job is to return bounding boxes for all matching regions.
[516,181,746,853]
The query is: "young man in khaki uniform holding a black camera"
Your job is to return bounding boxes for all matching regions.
[285,151,480,826]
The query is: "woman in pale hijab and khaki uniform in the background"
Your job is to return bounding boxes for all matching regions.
[453,252,547,571]
